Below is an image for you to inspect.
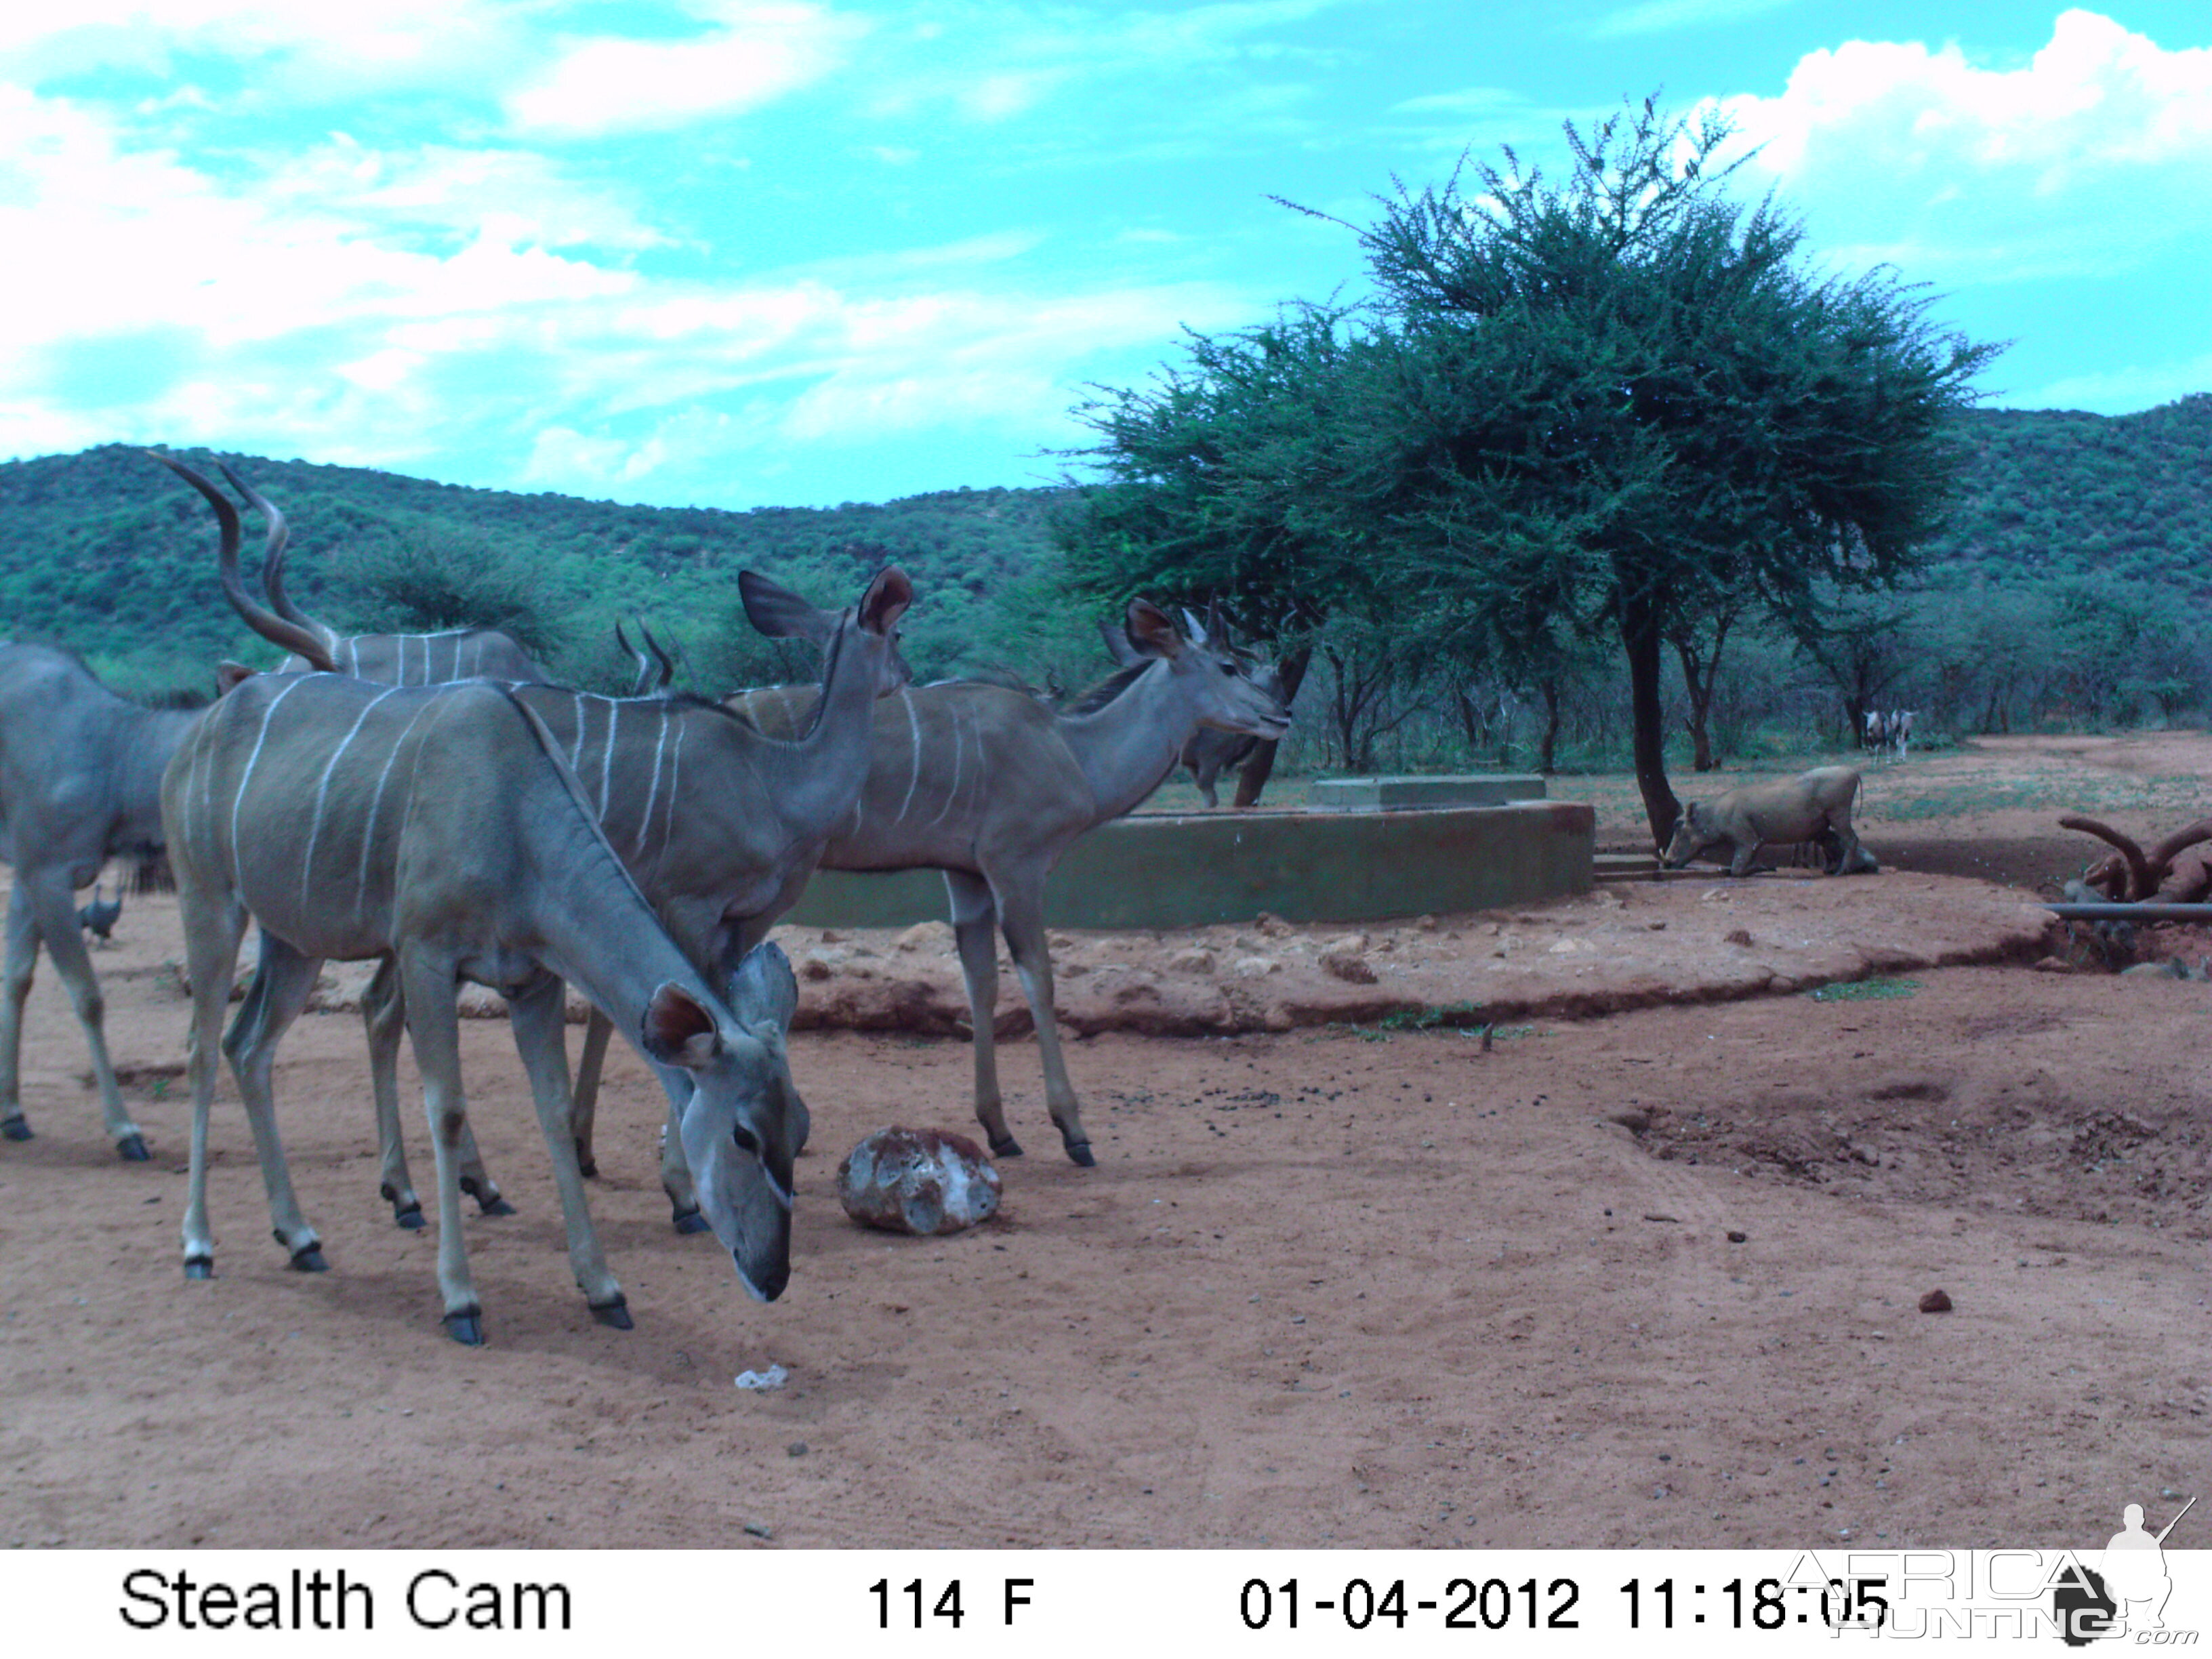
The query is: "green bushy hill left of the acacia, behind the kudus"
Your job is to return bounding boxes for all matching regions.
[0,445,1062,690]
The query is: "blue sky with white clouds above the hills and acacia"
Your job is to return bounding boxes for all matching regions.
[0,0,2212,506]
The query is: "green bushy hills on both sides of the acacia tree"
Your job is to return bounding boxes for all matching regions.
[0,394,2212,712]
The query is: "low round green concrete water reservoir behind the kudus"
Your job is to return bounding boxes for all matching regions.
[785,801,1597,929]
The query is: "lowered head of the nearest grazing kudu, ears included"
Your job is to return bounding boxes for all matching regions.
[639,945,798,1303]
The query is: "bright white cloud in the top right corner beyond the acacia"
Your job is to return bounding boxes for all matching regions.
[1721,11,2212,283]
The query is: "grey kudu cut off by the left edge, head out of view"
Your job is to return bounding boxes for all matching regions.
[0,642,199,1162]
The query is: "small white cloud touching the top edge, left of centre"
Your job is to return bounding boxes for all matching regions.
[506,2,867,137]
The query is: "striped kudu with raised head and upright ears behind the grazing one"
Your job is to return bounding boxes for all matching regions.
[179,455,914,1232]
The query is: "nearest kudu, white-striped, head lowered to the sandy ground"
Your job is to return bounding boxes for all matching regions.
[161,655,796,1345]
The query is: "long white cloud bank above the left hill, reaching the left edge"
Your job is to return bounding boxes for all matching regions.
[0,76,1252,489]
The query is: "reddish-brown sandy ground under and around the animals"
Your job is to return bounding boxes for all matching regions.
[0,735,2212,1549]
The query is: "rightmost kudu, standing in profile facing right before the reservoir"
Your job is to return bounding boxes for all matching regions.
[575,600,1290,1166]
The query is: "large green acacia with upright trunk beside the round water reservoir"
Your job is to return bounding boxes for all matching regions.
[1064,100,1997,840]
